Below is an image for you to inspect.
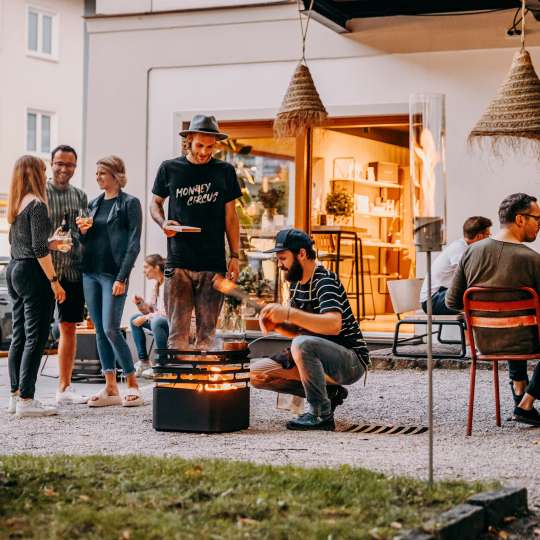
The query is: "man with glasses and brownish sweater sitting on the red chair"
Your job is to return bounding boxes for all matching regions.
[446,193,540,426]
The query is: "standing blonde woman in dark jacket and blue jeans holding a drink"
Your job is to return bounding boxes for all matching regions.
[77,156,143,407]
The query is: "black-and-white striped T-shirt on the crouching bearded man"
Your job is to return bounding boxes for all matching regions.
[290,265,370,366]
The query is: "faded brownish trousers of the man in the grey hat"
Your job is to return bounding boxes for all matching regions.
[165,268,223,350]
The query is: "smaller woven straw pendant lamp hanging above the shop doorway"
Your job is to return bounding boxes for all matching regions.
[274,0,328,137]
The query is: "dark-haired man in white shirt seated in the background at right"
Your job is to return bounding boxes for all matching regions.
[420,216,492,315]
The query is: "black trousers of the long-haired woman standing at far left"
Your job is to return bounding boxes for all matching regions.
[7,259,54,398]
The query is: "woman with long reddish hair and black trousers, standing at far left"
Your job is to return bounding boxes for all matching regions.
[7,156,66,417]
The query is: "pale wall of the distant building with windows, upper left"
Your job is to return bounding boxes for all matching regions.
[0,0,84,255]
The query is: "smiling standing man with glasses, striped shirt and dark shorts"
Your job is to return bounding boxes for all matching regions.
[47,145,88,405]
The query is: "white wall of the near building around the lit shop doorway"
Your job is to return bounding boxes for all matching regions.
[85,6,540,300]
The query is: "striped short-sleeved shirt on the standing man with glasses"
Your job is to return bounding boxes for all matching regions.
[47,180,88,281]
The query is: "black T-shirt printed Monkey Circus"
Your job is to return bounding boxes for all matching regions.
[152,156,241,273]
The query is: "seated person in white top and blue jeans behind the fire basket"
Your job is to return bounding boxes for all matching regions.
[129,253,169,375]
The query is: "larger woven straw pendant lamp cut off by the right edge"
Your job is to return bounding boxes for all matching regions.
[468,1,540,155]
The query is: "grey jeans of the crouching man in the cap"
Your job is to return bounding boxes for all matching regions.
[250,335,364,416]
